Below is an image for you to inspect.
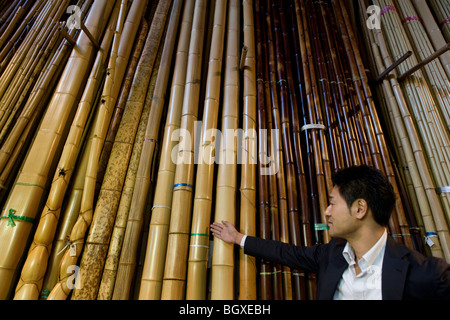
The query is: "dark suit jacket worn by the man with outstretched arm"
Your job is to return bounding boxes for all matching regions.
[244,237,450,300]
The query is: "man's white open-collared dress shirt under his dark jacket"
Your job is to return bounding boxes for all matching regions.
[333,230,387,300]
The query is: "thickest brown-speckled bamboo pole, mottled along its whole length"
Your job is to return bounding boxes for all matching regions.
[72,1,165,300]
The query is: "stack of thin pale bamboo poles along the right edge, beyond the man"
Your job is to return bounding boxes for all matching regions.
[374,0,450,260]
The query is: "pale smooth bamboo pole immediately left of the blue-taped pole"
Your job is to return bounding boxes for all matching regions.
[139,0,195,300]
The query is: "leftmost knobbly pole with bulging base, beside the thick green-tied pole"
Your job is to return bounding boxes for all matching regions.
[14,10,117,300]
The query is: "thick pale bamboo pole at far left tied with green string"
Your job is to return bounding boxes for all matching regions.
[0,1,113,299]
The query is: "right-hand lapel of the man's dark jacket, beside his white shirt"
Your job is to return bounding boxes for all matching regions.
[381,237,409,300]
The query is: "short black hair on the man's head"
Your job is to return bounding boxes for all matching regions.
[332,165,396,226]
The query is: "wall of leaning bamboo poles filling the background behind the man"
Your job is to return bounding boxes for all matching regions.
[0,0,444,300]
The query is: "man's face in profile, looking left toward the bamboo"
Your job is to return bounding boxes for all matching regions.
[325,187,357,239]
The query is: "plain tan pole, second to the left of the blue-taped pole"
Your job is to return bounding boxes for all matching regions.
[113,0,183,299]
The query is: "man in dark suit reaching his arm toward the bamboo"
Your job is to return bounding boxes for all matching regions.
[211,166,450,300]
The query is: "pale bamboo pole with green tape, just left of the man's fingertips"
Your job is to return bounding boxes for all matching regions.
[186,0,227,300]
